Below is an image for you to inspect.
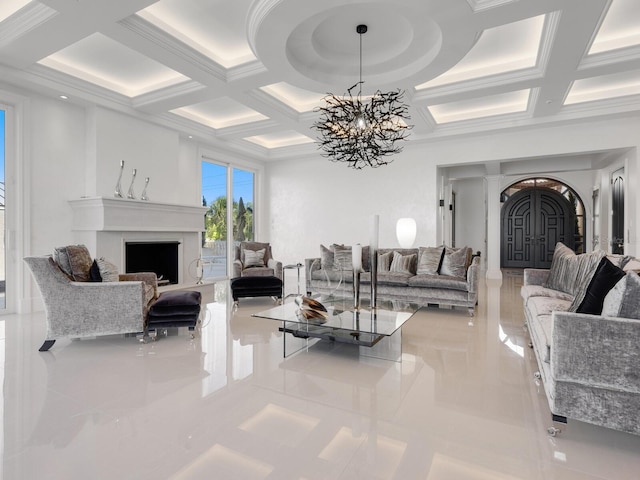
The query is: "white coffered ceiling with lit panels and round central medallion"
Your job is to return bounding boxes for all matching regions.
[0,0,640,160]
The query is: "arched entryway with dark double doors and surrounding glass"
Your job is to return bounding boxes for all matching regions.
[500,178,586,268]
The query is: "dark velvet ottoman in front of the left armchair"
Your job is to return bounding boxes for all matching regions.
[146,290,202,337]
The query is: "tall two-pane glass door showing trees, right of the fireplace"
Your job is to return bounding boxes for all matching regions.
[202,160,255,278]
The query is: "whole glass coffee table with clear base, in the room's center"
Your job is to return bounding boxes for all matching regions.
[252,296,420,362]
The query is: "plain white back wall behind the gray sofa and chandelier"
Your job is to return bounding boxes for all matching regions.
[266,152,437,263]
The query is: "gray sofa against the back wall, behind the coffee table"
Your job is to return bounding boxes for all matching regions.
[305,244,480,316]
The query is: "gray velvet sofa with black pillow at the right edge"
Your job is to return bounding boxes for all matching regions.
[521,244,640,435]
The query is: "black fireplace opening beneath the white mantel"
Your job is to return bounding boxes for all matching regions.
[124,242,180,285]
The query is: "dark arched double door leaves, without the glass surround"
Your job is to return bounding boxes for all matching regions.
[500,188,575,268]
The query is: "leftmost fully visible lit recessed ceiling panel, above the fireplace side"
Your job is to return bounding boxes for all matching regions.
[39,33,188,97]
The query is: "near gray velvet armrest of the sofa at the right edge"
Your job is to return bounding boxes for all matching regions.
[551,312,640,393]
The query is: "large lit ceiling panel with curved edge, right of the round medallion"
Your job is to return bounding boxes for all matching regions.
[416,15,545,90]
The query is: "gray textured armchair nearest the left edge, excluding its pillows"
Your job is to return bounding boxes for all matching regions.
[24,246,158,352]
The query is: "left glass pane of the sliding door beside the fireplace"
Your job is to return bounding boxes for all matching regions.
[202,161,228,278]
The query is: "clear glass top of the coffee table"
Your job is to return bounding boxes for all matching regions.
[252,296,420,335]
